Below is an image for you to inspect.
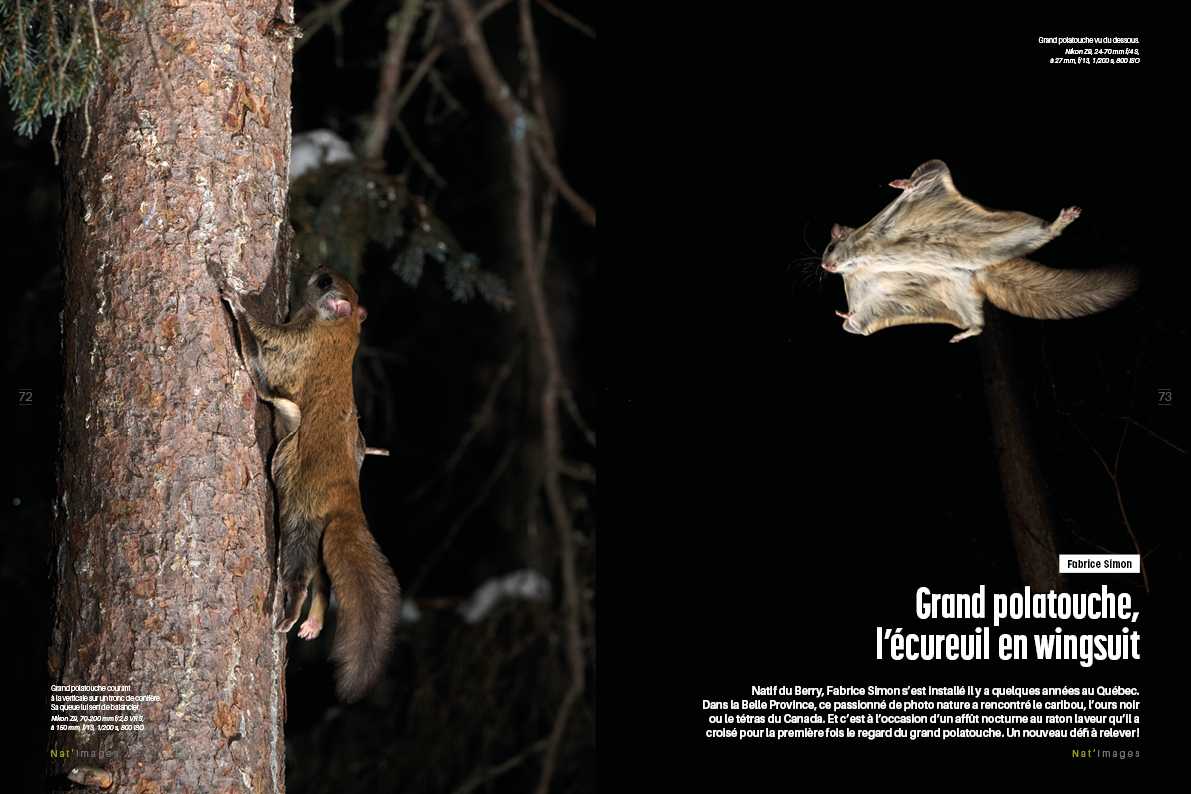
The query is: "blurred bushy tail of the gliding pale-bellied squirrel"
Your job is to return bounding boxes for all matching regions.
[977,258,1140,320]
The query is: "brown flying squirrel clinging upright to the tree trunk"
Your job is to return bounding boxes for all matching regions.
[216,268,401,702]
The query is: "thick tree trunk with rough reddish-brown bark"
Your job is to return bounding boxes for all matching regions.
[48,0,300,792]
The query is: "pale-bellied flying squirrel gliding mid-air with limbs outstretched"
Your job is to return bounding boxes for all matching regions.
[823,160,1137,342]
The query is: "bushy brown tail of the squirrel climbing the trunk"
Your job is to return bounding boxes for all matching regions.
[323,513,401,704]
